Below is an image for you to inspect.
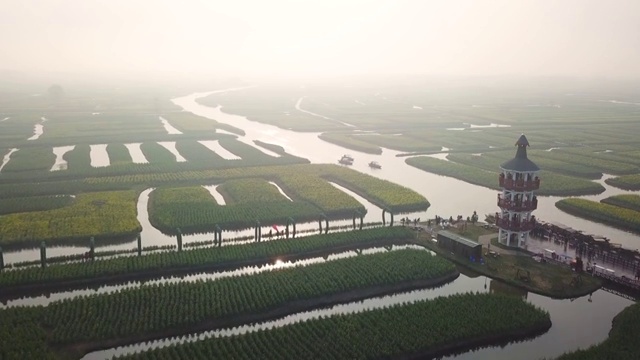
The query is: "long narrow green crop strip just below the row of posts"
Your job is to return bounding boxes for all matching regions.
[0,227,414,290]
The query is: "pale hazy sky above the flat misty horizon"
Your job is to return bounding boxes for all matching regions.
[0,0,640,77]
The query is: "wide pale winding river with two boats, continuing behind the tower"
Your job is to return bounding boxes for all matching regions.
[173,89,640,249]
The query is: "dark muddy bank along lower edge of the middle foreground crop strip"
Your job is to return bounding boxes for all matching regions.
[63,270,460,357]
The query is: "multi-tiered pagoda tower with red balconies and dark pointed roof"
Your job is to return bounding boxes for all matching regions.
[496,134,540,248]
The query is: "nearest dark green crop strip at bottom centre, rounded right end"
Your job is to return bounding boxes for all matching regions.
[112,294,551,359]
